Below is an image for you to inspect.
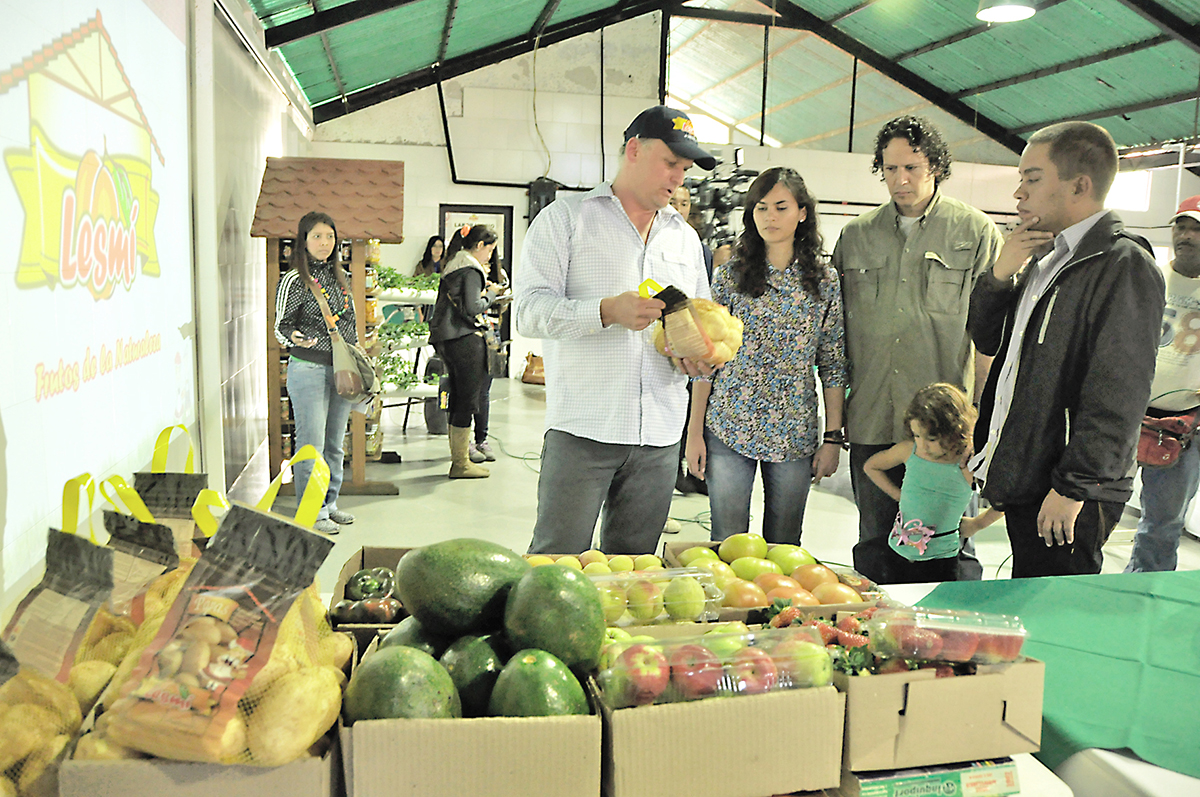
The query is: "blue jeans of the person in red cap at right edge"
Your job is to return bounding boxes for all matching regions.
[1124,443,1200,573]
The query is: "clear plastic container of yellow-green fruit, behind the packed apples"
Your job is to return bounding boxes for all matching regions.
[588,568,725,625]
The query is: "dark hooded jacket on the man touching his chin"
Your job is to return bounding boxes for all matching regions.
[967,212,1165,509]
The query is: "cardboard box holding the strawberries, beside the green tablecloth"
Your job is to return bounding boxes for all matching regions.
[834,659,1045,772]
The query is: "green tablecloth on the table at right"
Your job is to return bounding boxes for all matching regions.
[919,571,1200,778]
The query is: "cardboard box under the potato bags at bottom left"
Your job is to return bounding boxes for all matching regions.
[59,739,342,797]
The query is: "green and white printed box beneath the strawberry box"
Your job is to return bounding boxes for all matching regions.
[836,757,1021,797]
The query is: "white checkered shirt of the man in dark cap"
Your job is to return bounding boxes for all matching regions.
[512,182,710,447]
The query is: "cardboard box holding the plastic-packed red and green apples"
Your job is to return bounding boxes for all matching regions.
[588,623,845,797]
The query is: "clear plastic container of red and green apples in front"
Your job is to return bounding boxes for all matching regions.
[598,627,833,708]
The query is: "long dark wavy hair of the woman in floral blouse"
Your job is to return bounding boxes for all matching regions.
[732,167,824,298]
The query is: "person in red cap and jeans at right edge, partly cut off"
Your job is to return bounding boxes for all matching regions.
[1124,197,1200,573]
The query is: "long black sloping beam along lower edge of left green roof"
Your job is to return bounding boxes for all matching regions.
[312,0,666,125]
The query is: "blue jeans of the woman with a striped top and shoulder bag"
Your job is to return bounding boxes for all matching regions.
[288,356,353,520]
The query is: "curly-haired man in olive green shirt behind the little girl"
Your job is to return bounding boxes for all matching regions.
[833,116,1003,583]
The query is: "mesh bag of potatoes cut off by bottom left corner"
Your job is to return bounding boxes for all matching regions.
[0,642,82,797]
